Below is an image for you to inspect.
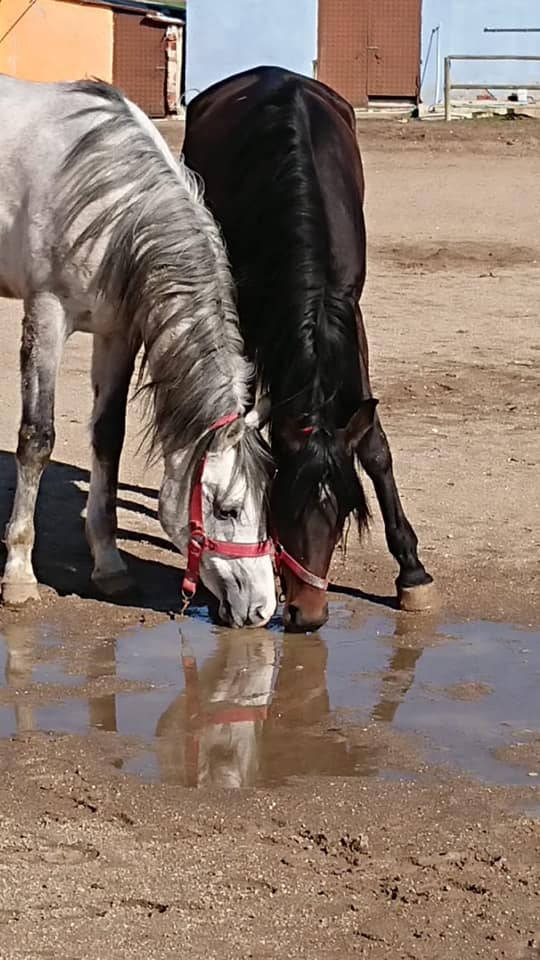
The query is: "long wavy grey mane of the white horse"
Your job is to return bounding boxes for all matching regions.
[57,81,267,484]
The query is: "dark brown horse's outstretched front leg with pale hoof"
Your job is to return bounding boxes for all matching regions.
[357,310,435,610]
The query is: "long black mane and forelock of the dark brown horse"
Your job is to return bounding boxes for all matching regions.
[186,68,369,526]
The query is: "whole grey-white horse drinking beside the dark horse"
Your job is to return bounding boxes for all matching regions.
[0,76,276,626]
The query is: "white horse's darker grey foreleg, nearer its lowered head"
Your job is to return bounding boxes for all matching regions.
[86,334,135,597]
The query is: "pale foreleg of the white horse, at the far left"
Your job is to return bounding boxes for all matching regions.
[2,294,66,605]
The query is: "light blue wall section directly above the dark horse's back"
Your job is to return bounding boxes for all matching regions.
[186,0,317,101]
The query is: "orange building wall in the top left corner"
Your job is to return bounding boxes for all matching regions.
[0,0,113,82]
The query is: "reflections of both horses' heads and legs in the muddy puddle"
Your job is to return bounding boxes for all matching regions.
[3,617,434,788]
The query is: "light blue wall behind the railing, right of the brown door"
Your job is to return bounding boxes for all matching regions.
[422,0,540,103]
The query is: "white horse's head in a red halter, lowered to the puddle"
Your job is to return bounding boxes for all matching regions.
[159,394,276,627]
